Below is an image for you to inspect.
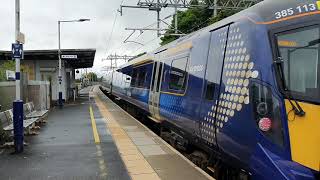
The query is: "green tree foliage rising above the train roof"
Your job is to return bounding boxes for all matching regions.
[160,4,237,45]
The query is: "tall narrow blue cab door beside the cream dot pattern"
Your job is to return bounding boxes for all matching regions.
[199,26,229,145]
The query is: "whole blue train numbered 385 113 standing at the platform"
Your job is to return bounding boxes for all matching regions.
[103,0,320,179]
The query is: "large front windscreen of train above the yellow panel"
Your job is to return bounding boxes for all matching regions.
[276,26,320,103]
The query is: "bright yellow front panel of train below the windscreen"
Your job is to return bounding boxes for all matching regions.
[285,100,320,171]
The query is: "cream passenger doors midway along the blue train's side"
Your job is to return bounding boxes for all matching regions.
[149,61,163,120]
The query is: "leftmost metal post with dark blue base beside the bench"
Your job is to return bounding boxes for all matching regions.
[13,0,24,153]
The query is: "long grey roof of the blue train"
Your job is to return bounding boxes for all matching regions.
[119,0,320,66]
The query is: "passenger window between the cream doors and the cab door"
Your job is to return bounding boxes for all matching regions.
[169,57,188,91]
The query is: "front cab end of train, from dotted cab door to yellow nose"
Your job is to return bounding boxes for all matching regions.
[194,1,320,179]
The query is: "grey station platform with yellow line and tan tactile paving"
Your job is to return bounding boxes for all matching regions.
[0,86,213,180]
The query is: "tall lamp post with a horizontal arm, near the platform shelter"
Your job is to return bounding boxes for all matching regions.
[58,19,90,108]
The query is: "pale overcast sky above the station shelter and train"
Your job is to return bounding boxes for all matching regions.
[0,0,173,75]
